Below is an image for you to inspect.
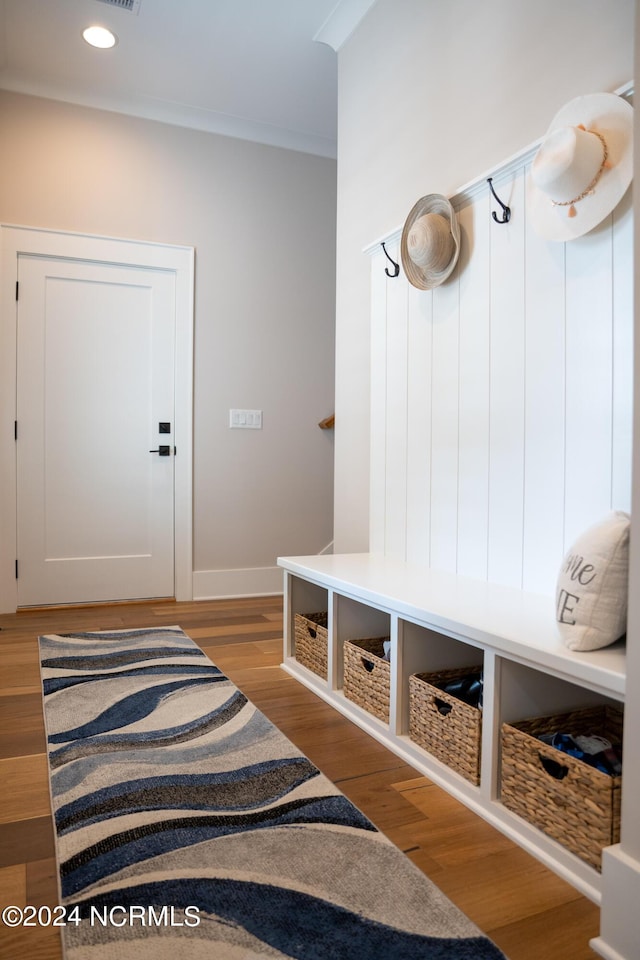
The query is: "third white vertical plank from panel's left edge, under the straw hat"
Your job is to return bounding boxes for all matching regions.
[407,286,433,564]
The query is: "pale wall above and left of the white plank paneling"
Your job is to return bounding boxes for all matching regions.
[334,0,634,551]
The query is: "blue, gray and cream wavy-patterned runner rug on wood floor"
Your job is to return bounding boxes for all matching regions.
[40,627,510,960]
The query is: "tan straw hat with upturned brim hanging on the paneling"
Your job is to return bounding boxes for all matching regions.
[400,193,460,290]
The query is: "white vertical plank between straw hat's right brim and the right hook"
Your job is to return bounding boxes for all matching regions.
[457,191,492,579]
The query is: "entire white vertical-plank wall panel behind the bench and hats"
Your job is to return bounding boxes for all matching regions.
[370,143,633,594]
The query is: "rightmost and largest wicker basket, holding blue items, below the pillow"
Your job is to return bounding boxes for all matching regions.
[502,706,623,870]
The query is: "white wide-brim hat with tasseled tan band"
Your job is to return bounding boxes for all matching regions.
[527,93,633,240]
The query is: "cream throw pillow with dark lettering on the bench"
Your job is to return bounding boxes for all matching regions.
[556,511,630,650]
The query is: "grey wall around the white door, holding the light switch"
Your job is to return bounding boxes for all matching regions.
[0,93,335,596]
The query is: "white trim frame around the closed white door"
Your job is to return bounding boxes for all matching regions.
[0,224,195,613]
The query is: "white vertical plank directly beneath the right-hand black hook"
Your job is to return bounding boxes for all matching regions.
[488,170,525,587]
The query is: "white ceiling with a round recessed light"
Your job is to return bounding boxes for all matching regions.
[0,0,375,157]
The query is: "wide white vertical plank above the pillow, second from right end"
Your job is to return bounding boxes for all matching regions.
[564,218,613,547]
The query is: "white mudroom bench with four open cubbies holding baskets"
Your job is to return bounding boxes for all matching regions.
[278,553,625,903]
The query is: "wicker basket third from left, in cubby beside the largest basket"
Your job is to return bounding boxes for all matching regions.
[409,667,482,784]
